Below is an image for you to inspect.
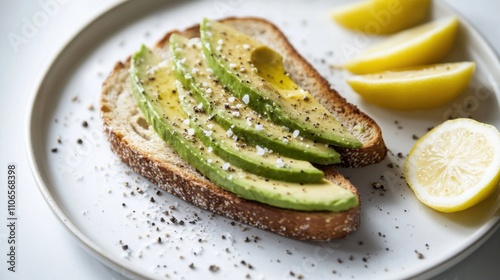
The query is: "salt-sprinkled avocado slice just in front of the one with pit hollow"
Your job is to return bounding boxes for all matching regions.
[170,34,340,164]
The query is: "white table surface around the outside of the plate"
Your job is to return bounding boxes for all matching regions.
[0,0,500,280]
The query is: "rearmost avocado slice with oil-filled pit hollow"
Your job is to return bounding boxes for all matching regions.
[200,19,362,148]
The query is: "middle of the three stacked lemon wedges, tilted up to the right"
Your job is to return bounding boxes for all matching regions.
[344,17,458,74]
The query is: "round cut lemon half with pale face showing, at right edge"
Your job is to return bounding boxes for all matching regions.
[404,118,500,212]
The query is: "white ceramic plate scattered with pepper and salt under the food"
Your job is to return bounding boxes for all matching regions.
[28,0,500,279]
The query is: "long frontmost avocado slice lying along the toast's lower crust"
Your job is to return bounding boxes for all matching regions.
[130,46,358,212]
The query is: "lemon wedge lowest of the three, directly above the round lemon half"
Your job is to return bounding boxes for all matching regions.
[347,62,475,110]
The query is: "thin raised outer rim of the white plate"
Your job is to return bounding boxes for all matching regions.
[25,0,500,279]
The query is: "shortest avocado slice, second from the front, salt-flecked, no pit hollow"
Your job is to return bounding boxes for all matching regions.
[176,81,323,183]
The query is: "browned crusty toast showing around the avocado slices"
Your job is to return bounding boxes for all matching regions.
[101,18,387,241]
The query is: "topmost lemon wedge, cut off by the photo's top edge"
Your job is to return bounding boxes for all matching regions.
[330,0,431,34]
